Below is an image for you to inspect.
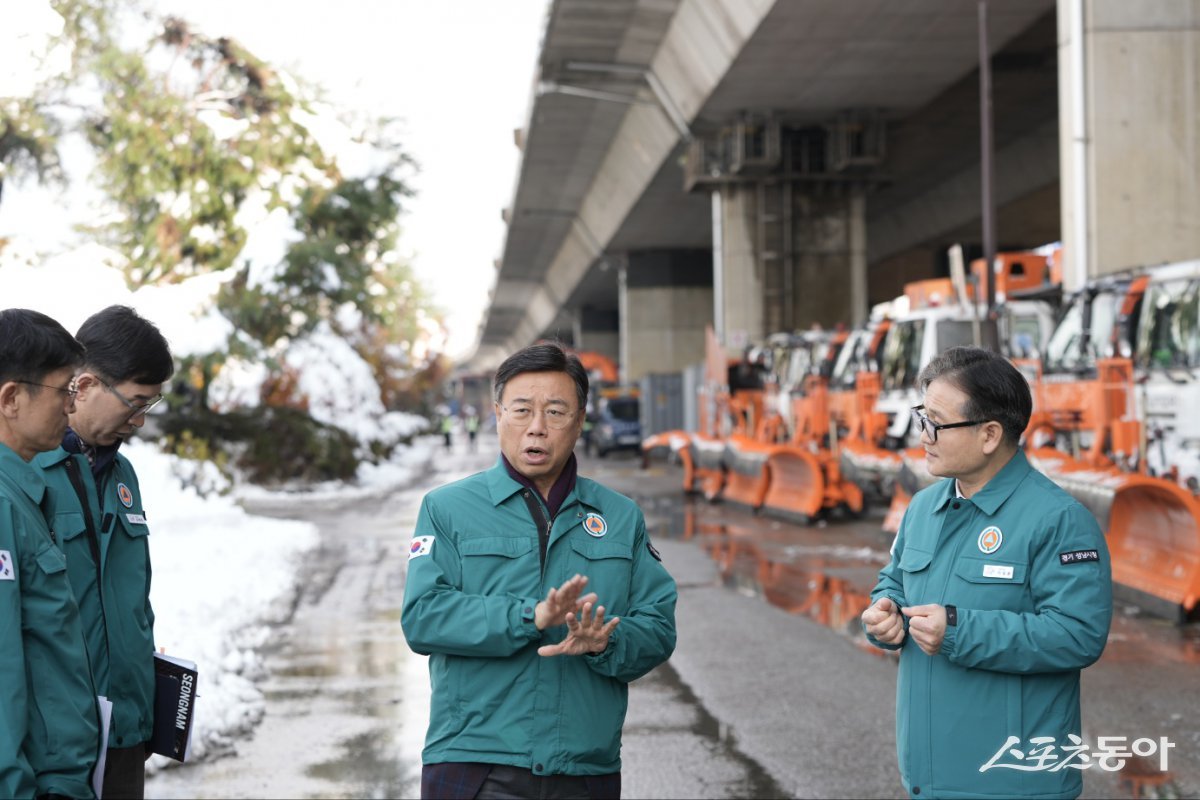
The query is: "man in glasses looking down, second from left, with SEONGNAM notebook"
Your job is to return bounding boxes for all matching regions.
[35,306,175,800]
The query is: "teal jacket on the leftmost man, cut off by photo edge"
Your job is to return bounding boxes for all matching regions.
[0,445,100,799]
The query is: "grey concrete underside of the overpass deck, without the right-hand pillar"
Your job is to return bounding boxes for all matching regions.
[473,0,1060,369]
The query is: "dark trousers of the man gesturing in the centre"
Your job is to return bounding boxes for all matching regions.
[421,763,620,800]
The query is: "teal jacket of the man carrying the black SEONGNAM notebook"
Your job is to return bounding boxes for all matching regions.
[34,447,155,747]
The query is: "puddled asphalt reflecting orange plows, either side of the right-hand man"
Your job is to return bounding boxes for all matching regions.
[643,484,1200,799]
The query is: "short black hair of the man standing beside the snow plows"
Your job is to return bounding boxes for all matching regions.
[917,347,1033,445]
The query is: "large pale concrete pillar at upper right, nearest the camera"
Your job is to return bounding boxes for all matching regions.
[1058,0,1200,288]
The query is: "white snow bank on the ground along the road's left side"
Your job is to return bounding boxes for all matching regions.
[130,440,433,771]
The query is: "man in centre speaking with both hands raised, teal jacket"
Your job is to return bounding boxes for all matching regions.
[402,344,676,798]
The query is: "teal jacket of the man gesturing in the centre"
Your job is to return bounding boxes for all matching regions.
[401,462,676,775]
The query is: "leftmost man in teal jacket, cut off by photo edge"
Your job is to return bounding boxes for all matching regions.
[0,308,100,799]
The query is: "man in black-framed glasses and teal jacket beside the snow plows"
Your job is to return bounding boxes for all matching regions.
[863,348,1112,800]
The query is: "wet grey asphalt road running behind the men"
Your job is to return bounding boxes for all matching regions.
[146,437,1200,798]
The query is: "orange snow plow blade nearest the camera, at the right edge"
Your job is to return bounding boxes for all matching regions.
[1033,449,1200,616]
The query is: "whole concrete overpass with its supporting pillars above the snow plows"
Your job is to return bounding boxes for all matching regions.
[470,0,1200,379]
